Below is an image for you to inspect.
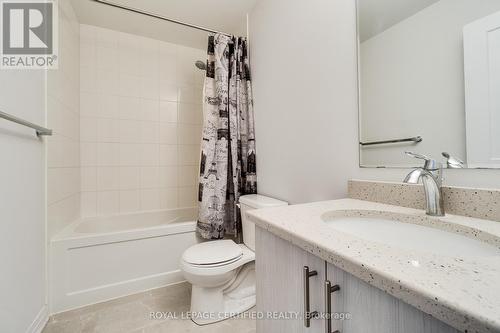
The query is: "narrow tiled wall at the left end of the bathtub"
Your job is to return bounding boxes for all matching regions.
[47,1,80,240]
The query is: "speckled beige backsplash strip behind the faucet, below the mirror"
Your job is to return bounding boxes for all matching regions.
[348,180,500,222]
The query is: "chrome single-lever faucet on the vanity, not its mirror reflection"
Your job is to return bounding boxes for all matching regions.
[404,152,444,216]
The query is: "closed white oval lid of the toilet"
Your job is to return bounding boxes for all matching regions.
[182,240,243,265]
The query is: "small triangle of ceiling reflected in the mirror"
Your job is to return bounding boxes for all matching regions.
[358,0,439,42]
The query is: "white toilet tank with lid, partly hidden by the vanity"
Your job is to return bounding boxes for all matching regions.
[240,194,288,251]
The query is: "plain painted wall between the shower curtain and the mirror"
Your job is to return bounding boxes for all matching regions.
[249,0,358,203]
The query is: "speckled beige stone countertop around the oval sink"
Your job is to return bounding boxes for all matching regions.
[247,199,500,333]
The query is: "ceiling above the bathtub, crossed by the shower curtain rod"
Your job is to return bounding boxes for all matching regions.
[71,0,256,49]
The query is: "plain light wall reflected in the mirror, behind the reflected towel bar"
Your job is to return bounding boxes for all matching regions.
[360,0,500,166]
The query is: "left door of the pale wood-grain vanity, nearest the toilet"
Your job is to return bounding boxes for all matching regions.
[255,228,325,333]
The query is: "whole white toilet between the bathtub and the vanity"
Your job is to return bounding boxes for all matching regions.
[181,194,287,325]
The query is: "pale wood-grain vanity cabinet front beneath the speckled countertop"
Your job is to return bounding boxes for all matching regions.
[256,228,459,333]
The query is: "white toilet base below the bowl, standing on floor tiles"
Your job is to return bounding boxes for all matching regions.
[191,262,256,325]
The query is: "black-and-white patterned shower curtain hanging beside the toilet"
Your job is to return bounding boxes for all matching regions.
[197,34,257,239]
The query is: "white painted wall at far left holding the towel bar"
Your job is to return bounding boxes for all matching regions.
[0,39,48,332]
